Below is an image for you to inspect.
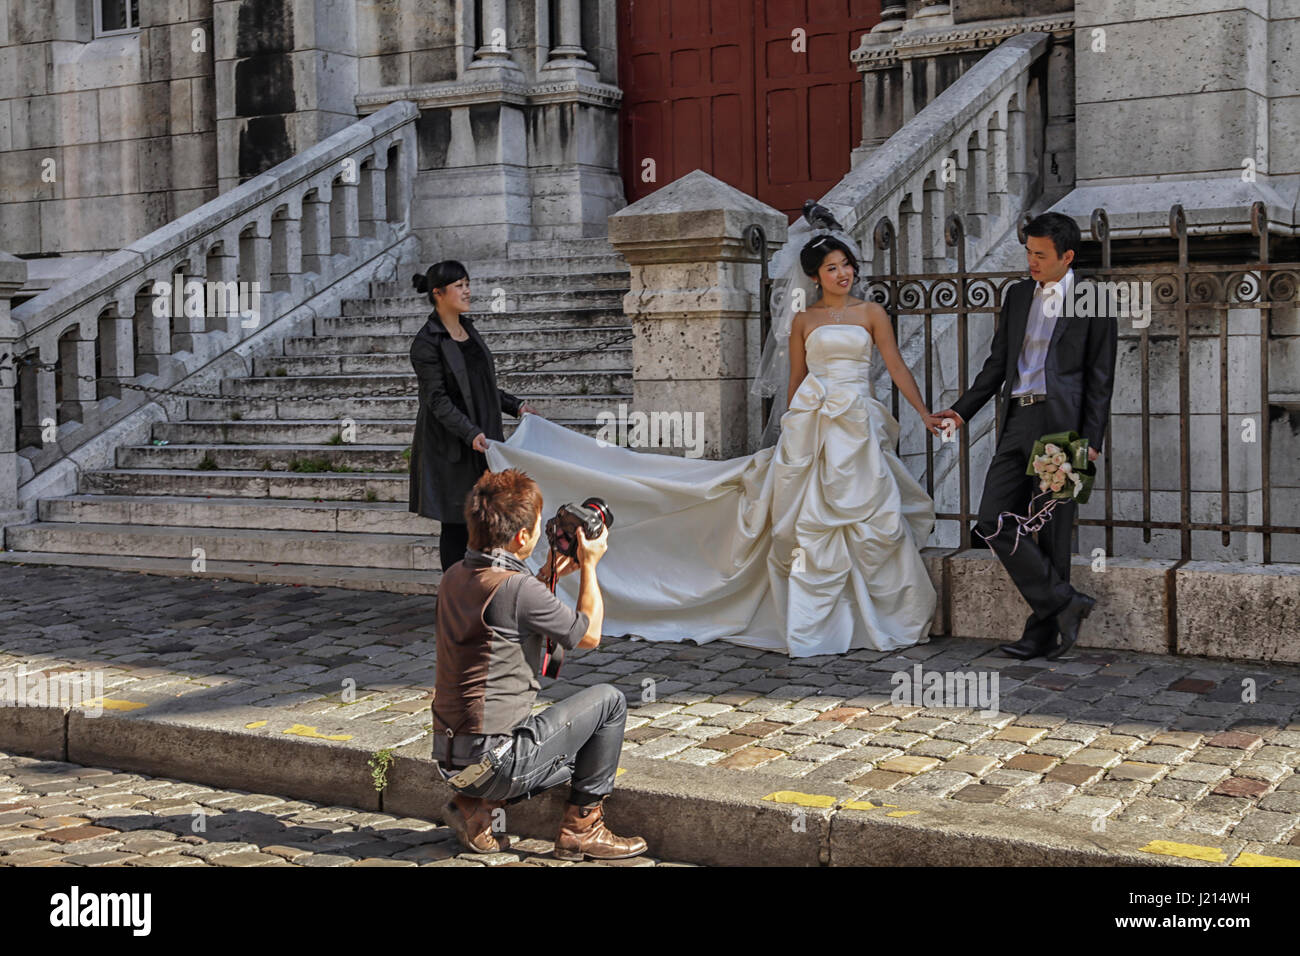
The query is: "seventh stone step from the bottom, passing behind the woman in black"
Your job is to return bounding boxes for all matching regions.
[186,393,628,421]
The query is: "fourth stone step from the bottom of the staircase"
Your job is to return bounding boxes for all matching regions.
[77,468,411,502]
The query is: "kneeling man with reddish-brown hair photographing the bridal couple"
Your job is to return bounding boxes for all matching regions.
[433,468,646,860]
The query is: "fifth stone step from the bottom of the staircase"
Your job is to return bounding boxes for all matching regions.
[117,444,411,475]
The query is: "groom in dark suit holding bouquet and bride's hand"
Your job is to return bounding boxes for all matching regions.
[932,212,1118,661]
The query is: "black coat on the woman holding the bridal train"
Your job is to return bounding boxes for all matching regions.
[408,310,521,524]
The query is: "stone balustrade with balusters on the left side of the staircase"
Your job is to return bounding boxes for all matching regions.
[0,101,419,511]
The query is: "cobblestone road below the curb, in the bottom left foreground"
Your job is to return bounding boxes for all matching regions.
[0,753,684,866]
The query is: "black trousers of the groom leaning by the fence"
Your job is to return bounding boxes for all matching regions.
[975,399,1076,637]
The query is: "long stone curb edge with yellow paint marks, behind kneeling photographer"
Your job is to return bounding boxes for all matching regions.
[0,708,1300,866]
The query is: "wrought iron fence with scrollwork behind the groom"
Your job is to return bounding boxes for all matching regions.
[847,203,1300,563]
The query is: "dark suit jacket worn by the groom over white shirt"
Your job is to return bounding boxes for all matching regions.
[953,274,1119,451]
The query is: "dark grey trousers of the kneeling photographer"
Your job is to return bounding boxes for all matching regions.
[443,684,628,803]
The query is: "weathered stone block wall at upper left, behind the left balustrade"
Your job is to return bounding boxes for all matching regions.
[0,0,217,255]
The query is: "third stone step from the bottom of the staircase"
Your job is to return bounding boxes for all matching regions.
[36,494,442,537]
